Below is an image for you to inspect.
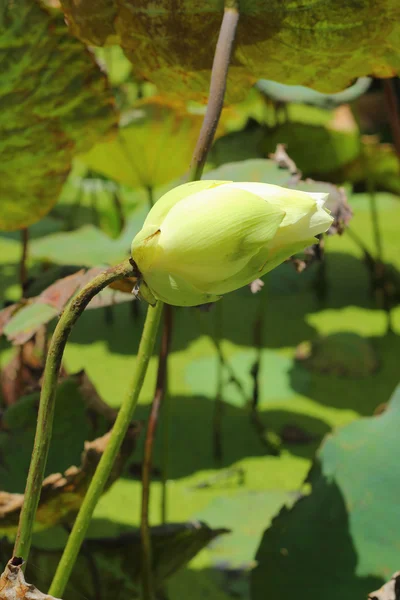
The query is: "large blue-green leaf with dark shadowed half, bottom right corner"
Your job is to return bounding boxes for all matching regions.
[252,387,400,600]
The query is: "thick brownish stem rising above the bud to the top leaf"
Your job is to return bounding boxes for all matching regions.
[189,0,239,181]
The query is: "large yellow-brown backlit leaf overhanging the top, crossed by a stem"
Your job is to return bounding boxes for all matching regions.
[58,0,400,98]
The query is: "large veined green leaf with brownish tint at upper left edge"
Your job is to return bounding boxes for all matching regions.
[0,0,116,230]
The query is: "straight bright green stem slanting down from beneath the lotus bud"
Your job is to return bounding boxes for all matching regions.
[49,301,163,597]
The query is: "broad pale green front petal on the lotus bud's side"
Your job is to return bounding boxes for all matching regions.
[150,185,285,293]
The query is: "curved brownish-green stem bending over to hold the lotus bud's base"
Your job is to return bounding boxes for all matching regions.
[14,260,134,561]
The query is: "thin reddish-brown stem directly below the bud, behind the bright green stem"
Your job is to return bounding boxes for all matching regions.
[140,305,172,598]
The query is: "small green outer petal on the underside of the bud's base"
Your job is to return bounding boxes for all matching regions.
[145,270,221,306]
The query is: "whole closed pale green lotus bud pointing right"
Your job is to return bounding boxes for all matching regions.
[132,181,332,306]
